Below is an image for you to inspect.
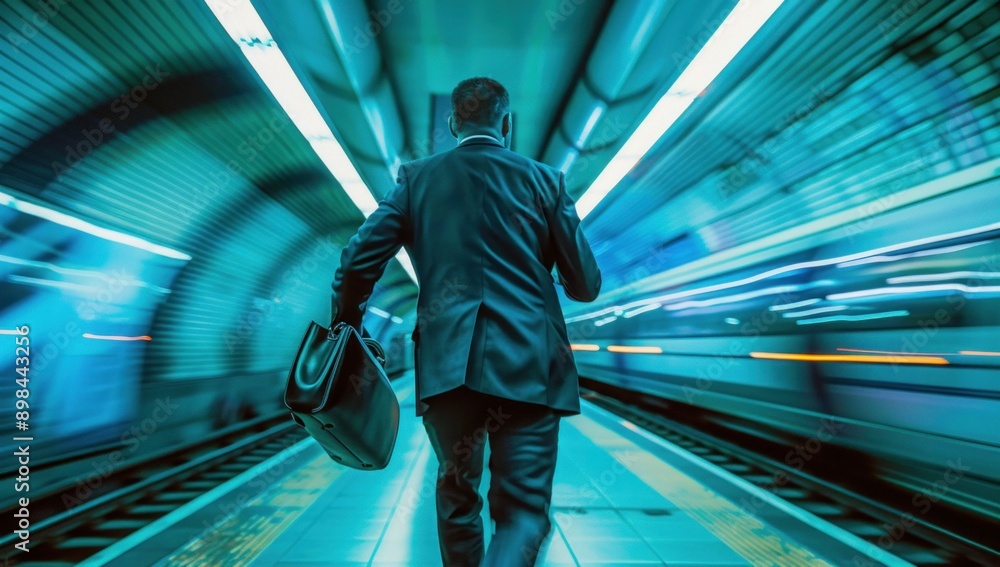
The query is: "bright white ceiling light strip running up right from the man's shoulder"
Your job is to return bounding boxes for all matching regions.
[576,0,783,218]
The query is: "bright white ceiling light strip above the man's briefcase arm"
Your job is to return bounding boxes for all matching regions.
[205,0,417,282]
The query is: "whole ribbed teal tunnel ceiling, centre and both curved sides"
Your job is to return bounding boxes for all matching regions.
[0,0,997,362]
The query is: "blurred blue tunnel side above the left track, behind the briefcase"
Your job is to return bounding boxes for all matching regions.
[0,188,412,492]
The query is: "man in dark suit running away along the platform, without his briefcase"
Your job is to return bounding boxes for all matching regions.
[333,77,601,567]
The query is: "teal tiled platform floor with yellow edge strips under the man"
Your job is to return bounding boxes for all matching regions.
[88,382,903,567]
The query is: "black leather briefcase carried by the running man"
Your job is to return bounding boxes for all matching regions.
[285,322,399,470]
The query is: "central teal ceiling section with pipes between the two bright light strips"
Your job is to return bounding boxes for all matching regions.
[244,0,735,312]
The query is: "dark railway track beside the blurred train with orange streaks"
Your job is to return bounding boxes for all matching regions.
[581,388,1000,566]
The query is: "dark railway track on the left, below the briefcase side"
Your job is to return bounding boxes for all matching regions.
[0,411,305,567]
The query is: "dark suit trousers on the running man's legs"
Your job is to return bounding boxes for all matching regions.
[423,386,560,567]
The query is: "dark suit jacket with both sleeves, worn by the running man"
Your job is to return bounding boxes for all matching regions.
[333,138,601,415]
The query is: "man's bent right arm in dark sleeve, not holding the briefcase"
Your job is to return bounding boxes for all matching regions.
[548,172,601,302]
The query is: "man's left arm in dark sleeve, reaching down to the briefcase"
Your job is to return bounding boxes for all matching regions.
[331,166,411,329]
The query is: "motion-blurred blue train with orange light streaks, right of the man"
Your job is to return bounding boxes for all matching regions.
[567,179,1000,518]
